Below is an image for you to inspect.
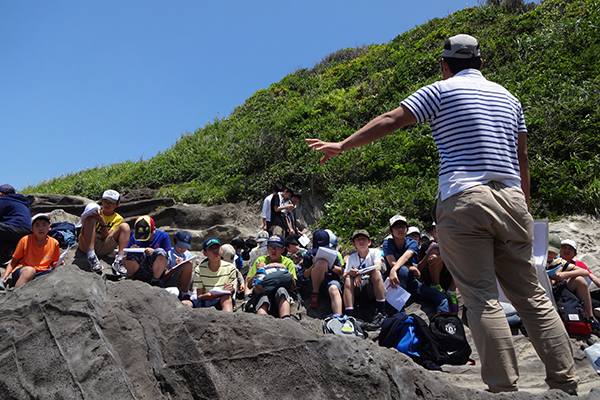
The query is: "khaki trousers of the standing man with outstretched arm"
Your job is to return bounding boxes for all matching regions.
[436,182,578,392]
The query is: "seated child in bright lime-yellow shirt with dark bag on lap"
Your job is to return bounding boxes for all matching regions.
[246,235,296,319]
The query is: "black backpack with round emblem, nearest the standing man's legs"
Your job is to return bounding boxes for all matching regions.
[429,313,471,365]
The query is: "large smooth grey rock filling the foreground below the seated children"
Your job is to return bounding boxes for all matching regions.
[0,266,599,400]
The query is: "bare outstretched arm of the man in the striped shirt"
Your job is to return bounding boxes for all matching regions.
[306,106,417,164]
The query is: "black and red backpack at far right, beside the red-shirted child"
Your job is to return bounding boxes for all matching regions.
[552,284,592,339]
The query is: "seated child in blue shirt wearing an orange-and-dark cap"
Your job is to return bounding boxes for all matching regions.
[124,215,171,287]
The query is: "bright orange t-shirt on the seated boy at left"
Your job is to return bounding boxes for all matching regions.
[13,234,60,271]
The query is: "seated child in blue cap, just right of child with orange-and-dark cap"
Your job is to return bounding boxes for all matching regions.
[162,231,194,300]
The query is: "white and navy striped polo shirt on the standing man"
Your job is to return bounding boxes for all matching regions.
[402,69,527,200]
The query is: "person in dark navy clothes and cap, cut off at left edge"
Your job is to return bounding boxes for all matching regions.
[0,184,32,264]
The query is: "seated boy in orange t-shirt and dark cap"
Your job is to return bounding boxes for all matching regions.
[2,214,60,287]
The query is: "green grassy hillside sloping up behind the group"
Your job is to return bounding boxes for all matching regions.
[25,0,600,241]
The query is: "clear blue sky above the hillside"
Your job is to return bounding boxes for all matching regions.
[0,0,476,190]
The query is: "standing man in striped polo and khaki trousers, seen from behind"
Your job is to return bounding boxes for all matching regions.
[306,35,578,394]
